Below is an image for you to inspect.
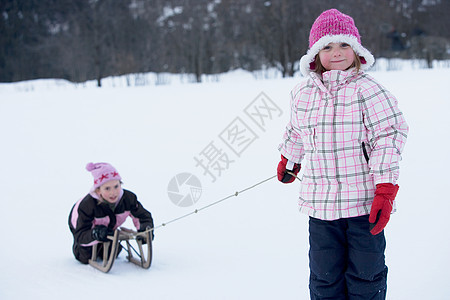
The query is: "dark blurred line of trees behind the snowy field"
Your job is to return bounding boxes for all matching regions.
[0,0,450,85]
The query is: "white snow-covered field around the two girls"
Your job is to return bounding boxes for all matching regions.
[0,69,450,300]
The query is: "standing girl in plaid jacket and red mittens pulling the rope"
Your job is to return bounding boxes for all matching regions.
[277,9,408,300]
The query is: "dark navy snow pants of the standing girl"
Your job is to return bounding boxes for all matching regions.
[309,215,388,300]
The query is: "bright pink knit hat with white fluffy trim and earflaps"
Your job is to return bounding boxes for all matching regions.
[300,9,375,76]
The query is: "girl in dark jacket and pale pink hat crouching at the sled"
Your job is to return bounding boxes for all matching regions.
[69,163,153,264]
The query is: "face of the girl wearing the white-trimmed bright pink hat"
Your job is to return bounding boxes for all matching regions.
[319,43,355,71]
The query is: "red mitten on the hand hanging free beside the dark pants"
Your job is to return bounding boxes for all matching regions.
[369,183,398,235]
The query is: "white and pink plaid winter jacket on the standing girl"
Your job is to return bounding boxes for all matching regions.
[279,70,408,220]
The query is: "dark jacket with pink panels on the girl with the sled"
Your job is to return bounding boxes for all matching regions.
[69,190,153,247]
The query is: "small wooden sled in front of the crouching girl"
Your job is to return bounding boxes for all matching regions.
[89,227,152,273]
